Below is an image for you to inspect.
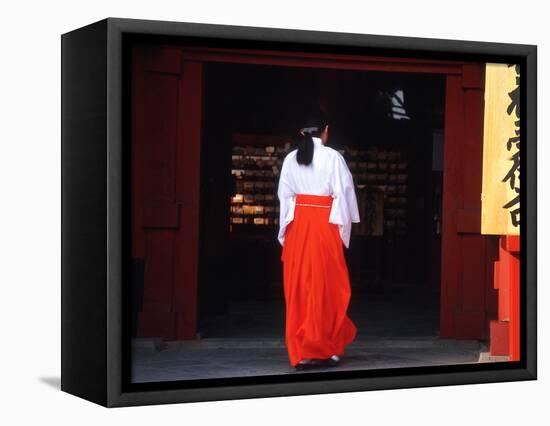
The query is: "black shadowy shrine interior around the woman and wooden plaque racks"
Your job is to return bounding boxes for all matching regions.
[198,63,445,337]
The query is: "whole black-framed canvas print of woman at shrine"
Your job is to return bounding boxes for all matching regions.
[61,18,537,407]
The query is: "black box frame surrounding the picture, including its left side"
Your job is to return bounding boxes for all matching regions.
[61,18,537,407]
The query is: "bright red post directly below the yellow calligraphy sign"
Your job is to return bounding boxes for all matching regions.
[490,235,520,361]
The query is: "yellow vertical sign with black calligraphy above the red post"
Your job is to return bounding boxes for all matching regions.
[481,64,520,235]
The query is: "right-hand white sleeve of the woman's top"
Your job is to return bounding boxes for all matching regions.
[329,153,360,248]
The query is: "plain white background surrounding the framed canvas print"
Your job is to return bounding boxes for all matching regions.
[0,0,550,426]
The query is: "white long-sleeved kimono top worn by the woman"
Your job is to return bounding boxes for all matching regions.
[277,137,360,248]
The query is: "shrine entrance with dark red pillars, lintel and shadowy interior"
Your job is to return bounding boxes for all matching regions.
[132,46,496,340]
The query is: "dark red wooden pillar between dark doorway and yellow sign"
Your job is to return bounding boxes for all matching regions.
[440,64,496,339]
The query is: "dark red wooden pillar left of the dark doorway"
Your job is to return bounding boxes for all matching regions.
[131,47,202,340]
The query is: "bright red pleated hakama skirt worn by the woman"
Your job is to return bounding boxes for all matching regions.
[281,194,357,366]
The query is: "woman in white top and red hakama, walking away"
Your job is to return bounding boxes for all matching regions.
[278,112,359,370]
